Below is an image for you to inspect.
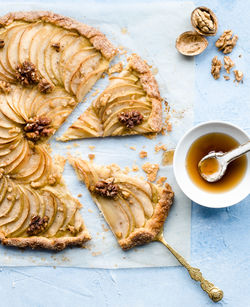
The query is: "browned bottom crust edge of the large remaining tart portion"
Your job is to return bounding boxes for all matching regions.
[0,231,91,251]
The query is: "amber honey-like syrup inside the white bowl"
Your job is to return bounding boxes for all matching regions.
[186,133,247,193]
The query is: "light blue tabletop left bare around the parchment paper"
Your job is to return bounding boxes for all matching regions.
[0,0,250,307]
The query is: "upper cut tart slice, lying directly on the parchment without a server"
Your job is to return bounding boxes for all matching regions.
[59,54,162,141]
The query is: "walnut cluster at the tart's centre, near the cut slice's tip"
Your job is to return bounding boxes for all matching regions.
[23,116,53,142]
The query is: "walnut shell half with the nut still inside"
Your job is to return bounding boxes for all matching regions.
[191,6,218,36]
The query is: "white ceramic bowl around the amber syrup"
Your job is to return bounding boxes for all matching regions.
[173,121,250,208]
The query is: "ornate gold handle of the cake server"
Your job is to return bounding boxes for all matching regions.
[157,233,223,302]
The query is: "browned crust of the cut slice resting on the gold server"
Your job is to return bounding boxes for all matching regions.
[119,183,174,250]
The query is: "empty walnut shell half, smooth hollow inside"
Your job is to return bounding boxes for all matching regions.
[175,31,208,56]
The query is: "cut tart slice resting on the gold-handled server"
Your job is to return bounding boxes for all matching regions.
[69,156,174,250]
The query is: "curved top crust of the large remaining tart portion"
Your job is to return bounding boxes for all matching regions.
[0,11,117,60]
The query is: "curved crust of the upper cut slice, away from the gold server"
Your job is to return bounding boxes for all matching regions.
[128,53,162,132]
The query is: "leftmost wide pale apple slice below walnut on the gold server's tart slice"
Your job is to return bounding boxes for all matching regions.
[94,196,130,239]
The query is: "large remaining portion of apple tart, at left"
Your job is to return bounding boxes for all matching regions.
[0,12,116,250]
